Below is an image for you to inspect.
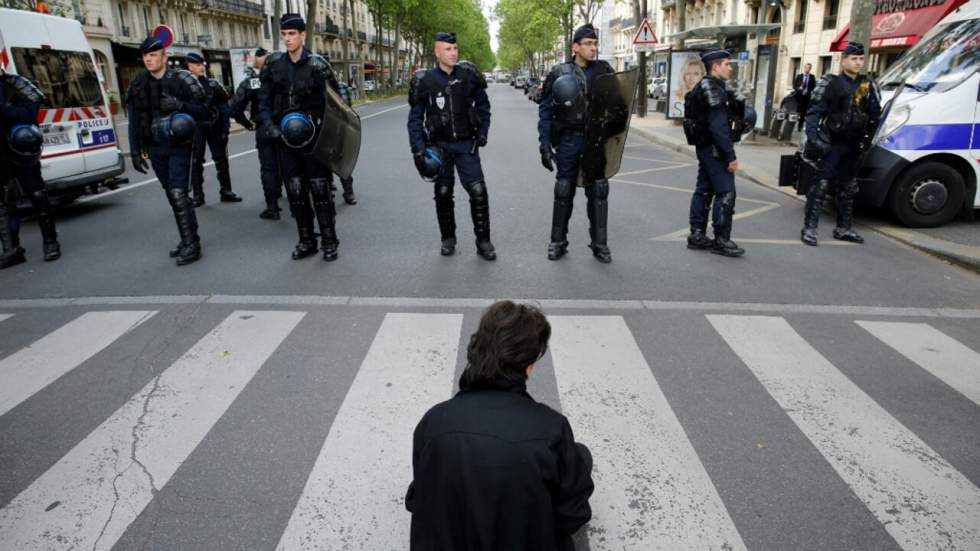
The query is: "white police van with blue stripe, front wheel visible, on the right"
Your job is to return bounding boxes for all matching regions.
[859,0,980,227]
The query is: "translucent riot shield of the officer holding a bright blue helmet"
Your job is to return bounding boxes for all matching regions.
[312,86,361,179]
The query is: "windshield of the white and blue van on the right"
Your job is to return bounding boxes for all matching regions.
[881,19,980,92]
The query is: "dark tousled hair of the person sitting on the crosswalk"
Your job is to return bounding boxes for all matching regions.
[459,300,551,388]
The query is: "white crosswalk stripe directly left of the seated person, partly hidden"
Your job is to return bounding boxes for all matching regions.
[277,313,463,550]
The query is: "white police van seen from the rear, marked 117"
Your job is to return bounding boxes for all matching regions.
[0,9,125,199]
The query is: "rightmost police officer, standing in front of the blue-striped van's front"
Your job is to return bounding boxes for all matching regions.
[800,42,881,246]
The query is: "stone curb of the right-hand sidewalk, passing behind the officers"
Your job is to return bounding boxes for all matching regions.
[630,126,980,274]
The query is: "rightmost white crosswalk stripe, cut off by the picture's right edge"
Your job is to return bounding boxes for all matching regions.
[854,321,980,405]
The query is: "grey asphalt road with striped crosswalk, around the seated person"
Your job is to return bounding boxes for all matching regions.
[0,85,980,551]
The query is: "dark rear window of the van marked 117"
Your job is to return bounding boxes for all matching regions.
[11,48,102,108]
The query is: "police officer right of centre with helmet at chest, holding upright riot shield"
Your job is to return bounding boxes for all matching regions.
[538,23,615,263]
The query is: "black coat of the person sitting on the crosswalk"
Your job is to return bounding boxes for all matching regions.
[405,384,593,551]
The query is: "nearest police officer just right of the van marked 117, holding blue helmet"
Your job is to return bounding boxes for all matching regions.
[126,31,208,266]
